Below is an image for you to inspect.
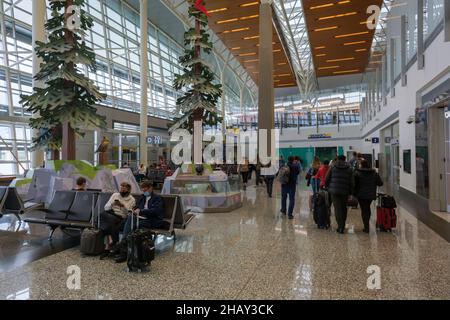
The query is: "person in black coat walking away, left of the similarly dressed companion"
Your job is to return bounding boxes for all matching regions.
[325,156,354,234]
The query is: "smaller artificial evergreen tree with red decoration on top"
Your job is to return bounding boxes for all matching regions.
[169,0,222,132]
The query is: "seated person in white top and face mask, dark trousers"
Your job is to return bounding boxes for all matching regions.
[100,182,136,259]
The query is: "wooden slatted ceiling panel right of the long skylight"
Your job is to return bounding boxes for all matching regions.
[302,0,382,77]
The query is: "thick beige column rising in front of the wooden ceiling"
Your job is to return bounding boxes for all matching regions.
[258,0,275,153]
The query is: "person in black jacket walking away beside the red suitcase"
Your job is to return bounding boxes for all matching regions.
[354,160,383,233]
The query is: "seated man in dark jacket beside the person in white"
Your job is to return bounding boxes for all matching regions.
[116,181,166,263]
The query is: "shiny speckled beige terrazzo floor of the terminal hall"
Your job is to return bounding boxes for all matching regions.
[0,182,450,299]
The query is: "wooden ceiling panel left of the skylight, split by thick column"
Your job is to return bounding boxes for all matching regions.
[206,0,297,88]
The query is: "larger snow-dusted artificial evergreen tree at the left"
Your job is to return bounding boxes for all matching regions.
[21,0,106,160]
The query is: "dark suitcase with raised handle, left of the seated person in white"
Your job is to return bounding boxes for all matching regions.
[80,194,105,256]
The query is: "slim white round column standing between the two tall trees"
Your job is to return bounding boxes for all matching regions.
[139,0,148,165]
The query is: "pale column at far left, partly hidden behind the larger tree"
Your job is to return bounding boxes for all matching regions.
[31,0,46,168]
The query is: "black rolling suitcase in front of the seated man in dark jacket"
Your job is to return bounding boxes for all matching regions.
[127,212,156,272]
